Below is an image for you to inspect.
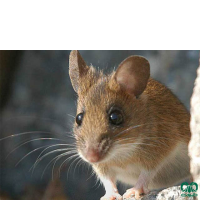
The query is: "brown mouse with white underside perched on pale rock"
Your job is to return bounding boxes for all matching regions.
[69,50,191,200]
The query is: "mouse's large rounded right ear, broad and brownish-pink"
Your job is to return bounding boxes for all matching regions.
[115,56,150,97]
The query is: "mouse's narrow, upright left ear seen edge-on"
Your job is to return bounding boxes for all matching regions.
[69,50,89,92]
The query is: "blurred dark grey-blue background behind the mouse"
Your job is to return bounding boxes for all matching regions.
[0,50,199,200]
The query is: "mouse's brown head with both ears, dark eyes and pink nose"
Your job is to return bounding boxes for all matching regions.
[69,51,150,163]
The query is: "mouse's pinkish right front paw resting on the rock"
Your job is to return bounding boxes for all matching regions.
[123,187,149,200]
